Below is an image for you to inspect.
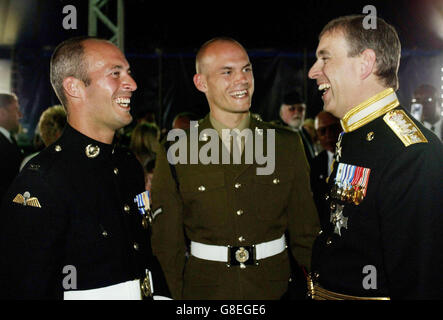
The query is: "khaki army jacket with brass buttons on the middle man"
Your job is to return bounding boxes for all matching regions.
[152,116,319,299]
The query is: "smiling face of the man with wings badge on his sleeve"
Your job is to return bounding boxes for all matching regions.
[83,40,137,131]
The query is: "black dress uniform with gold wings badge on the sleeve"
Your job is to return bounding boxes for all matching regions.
[0,125,169,299]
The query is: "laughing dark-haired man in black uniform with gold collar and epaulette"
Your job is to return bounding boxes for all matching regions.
[308,16,443,299]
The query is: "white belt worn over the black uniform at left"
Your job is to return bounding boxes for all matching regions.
[63,272,154,300]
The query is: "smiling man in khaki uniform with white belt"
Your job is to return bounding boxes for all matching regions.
[152,38,319,300]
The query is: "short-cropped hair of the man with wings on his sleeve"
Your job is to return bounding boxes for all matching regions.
[50,36,98,108]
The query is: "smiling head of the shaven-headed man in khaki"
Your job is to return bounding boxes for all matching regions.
[194,41,254,114]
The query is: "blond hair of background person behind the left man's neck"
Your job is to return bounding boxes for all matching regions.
[37,105,66,146]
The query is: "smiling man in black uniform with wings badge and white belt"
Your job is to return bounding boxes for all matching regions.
[0,38,168,299]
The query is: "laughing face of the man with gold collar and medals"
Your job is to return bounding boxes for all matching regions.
[308,30,361,118]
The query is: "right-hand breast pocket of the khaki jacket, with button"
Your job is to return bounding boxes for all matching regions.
[254,166,295,220]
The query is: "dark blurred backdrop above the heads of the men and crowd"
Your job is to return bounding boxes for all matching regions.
[0,0,443,138]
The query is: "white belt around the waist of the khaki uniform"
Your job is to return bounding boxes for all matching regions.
[191,235,286,263]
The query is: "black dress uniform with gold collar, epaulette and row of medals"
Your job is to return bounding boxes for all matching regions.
[309,89,443,299]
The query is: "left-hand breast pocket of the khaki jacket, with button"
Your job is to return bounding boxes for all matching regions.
[180,172,227,227]
